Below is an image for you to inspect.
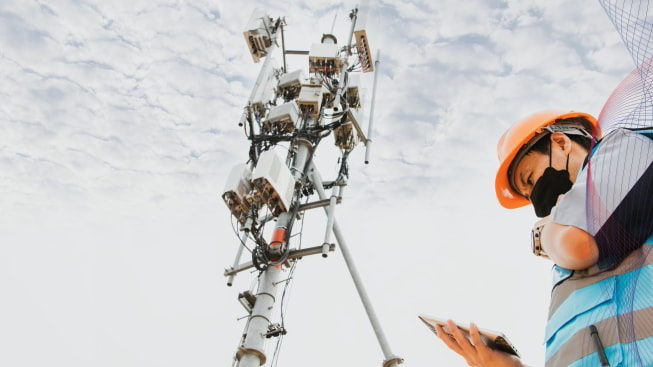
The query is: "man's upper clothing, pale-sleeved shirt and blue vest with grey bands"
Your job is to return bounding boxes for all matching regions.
[545,129,653,367]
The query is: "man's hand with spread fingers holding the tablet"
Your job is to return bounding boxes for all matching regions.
[435,320,524,367]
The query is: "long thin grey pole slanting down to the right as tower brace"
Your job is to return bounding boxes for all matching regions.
[309,164,403,367]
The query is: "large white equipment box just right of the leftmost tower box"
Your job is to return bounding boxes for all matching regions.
[252,150,295,212]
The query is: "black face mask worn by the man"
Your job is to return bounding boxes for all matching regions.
[531,149,573,218]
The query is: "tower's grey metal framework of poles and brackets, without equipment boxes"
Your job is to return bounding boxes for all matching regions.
[224,0,403,367]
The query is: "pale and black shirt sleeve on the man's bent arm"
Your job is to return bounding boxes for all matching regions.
[551,129,653,264]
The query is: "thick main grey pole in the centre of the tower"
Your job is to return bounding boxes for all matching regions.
[236,129,313,367]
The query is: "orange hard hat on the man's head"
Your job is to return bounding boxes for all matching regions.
[495,110,601,209]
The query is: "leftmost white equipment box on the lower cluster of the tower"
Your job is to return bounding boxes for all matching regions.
[222,163,252,224]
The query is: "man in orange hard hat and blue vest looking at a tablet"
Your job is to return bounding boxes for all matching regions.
[437,111,653,367]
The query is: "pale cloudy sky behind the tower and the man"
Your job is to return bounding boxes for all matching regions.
[0,0,633,366]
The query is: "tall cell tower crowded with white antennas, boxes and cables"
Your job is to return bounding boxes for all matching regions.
[222,1,403,367]
